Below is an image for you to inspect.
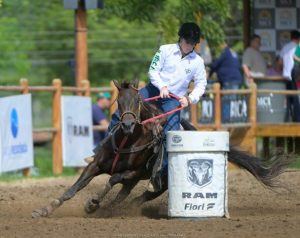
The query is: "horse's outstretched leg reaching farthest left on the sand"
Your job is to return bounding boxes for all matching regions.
[32,161,100,218]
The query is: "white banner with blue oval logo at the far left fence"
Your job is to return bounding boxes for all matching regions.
[0,94,33,172]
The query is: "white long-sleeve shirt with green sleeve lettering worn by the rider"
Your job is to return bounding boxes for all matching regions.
[148,44,207,104]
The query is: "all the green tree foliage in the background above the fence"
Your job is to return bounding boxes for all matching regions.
[0,0,233,86]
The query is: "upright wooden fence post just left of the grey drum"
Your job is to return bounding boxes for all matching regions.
[249,83,257,155]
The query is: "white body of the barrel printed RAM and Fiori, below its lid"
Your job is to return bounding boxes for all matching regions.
[168,152,229,218]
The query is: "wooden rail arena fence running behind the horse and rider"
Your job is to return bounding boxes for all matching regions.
[0,79,300,176]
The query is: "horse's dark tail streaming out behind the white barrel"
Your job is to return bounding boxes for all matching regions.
[180,119,293,188]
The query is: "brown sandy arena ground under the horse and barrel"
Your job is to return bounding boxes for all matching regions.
[0,170,300,238]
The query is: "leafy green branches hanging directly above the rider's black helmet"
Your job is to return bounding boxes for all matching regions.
[159,0,230,47]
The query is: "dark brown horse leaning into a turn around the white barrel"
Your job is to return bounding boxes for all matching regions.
[32,81,291,218]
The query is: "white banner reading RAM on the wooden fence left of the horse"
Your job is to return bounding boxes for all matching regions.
[61,96,93,167]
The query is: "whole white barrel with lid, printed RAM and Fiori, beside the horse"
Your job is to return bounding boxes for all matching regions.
[167,131,229,218]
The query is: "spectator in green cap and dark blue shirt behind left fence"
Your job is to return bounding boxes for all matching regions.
[92,92,111,146]
